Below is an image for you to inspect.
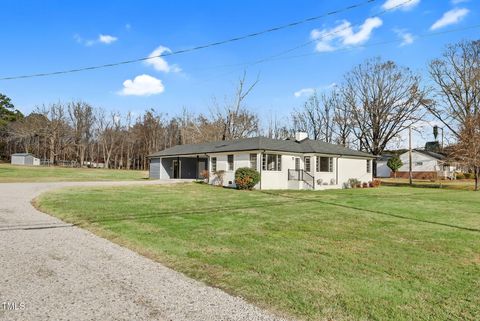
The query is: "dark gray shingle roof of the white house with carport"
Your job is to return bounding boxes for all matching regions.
[149,137,374,158]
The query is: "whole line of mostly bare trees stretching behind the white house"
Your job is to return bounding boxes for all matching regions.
[0,40,480,186]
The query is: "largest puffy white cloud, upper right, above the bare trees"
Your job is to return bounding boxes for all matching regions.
[310,17,383,52]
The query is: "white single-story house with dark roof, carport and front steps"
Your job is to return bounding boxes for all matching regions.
[149,133,374,189]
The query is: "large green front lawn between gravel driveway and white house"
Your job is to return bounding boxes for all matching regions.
[36,183,480,320]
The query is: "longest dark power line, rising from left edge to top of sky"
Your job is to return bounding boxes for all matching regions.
[0,0,378,80]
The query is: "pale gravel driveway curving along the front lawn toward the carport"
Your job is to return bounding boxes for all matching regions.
[0,181,286,321]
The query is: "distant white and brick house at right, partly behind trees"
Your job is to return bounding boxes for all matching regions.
[377,149,457,179]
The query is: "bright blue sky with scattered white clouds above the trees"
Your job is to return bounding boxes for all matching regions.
[0,0,480,145]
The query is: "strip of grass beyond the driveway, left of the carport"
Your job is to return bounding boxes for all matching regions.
[0,164,148,183]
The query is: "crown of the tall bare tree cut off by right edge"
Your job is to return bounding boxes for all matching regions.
[426,40,480,138]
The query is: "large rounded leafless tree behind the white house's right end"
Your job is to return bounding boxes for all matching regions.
[343,58,426,174]
